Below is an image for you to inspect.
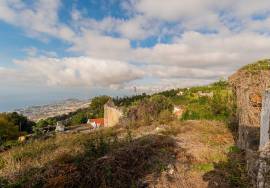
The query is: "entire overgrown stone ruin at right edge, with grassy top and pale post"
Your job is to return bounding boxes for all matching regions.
[229,60,270,188]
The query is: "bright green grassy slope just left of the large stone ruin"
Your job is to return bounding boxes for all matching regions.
[165,81,235,123]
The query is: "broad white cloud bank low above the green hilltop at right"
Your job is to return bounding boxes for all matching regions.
[135,32,270,73]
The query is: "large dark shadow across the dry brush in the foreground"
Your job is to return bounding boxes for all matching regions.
[9,135,180,188]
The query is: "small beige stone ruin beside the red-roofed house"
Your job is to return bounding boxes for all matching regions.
[104,100,123,127]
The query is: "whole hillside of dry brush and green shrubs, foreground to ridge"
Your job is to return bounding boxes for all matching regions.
[0,81,249,188]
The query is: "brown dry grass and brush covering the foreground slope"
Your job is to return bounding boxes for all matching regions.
[0,121,249,187]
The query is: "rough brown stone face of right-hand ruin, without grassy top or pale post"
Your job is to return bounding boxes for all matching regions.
[229,66,270,187]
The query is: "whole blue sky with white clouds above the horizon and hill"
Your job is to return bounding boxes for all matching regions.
[0,0,270,111]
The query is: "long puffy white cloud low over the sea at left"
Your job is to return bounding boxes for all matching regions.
[4,57,143,87]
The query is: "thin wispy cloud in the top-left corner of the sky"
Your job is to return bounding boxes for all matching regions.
[0,0,74,40]
